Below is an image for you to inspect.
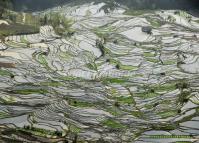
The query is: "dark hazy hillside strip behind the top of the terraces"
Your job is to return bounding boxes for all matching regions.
[13,0,199,11]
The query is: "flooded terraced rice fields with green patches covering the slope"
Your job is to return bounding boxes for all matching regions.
[0,3,199,143]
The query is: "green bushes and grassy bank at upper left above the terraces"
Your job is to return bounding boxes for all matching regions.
[0,10,75,38]
